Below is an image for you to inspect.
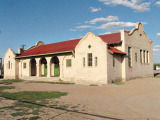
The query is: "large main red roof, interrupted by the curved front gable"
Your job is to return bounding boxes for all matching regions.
[17,33,121,57]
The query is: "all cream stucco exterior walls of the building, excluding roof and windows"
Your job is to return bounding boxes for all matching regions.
[4,23,153,85]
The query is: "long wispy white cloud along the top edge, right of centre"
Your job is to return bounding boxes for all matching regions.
[99,0,150,12]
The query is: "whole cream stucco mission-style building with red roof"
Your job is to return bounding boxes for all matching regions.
[4,23,153,85]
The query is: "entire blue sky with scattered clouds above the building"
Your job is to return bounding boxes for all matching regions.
[0,0,160,63]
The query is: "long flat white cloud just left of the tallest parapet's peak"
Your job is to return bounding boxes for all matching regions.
[98,22,136,29]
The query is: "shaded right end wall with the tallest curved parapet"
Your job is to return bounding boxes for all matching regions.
[122,23,153,80]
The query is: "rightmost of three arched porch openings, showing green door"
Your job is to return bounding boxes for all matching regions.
[51,56,60,76]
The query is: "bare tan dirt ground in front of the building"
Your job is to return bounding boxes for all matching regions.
[0,72,160,120]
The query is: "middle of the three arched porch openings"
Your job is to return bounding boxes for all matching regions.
[40,58,47,76]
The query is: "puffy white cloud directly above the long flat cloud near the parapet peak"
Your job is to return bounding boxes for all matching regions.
[89,16,119,24]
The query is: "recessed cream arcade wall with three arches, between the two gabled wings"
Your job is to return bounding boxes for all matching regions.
[19,54,75,82]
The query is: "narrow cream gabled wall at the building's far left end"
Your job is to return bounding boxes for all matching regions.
[4,48,16,79]
